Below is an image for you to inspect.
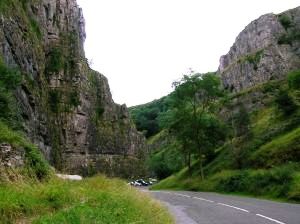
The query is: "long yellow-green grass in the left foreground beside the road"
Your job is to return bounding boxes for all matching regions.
[0,176,173,224]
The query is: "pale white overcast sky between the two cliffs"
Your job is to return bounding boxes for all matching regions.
[77,0,300,106]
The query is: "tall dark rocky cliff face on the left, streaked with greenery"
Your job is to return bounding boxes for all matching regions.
[0,0,145,177]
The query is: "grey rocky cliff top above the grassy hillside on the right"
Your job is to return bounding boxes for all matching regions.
[218,7,300,92]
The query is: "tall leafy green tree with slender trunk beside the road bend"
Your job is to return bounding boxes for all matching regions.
[170,73,224,179]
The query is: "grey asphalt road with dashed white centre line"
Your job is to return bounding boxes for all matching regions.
[149,191,300,224]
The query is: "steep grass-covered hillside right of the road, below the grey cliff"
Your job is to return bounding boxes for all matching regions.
[151,71,300,201]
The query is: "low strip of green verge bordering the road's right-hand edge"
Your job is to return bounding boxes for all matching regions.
[152,164,300,202]
